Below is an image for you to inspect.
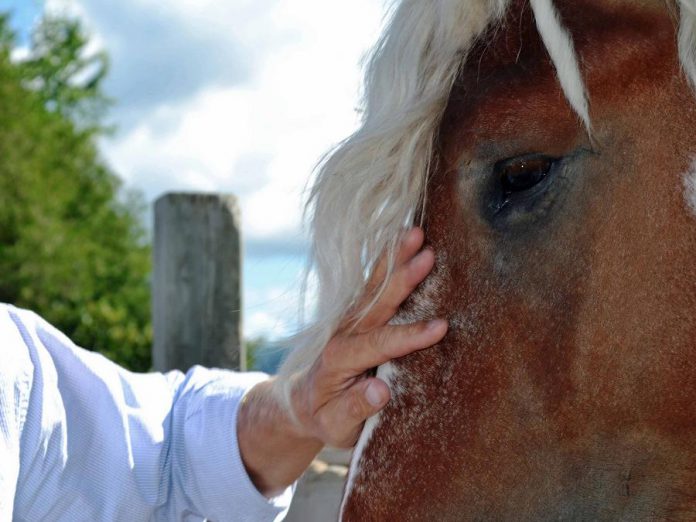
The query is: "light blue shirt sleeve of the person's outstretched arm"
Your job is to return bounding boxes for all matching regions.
[0,306,293,522]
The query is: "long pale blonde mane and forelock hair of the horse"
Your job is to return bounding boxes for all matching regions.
[276,0,696,406]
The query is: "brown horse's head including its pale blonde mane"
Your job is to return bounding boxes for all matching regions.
[281,0,696,522]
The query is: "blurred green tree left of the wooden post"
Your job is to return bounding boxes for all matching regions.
[0,16,152,370]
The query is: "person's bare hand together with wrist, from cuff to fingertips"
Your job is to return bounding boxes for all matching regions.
[237,228,447,497]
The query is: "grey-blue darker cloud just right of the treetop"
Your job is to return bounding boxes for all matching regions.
[47,0,250,112]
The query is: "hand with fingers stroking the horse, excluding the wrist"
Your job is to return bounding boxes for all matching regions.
[291,228,447,448]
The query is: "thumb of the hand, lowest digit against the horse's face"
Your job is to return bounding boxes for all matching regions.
[322,377,391,448]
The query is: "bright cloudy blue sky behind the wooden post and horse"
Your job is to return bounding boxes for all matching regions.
[0,0,386,339]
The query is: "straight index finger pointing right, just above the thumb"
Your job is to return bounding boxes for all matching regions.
[324,319,448,376]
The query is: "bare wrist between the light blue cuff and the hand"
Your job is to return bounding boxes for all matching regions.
[237,381,323,497]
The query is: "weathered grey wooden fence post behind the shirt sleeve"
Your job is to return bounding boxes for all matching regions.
[152,194,246,371]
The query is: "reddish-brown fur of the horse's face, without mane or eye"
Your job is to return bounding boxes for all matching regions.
[342,0,696,522]
